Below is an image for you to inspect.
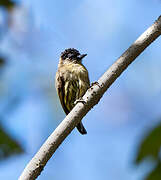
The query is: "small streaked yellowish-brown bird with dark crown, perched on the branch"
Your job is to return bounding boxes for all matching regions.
[55,48,90,134]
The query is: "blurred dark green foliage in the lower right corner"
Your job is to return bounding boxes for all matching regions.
[135,123,161,180]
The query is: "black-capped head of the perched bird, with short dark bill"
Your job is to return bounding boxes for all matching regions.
[61,48,87,63]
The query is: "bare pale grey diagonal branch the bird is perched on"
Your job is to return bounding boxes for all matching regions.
[19,16,161,180]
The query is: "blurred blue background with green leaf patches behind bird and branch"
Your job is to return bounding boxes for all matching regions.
[0,0,161,180]
